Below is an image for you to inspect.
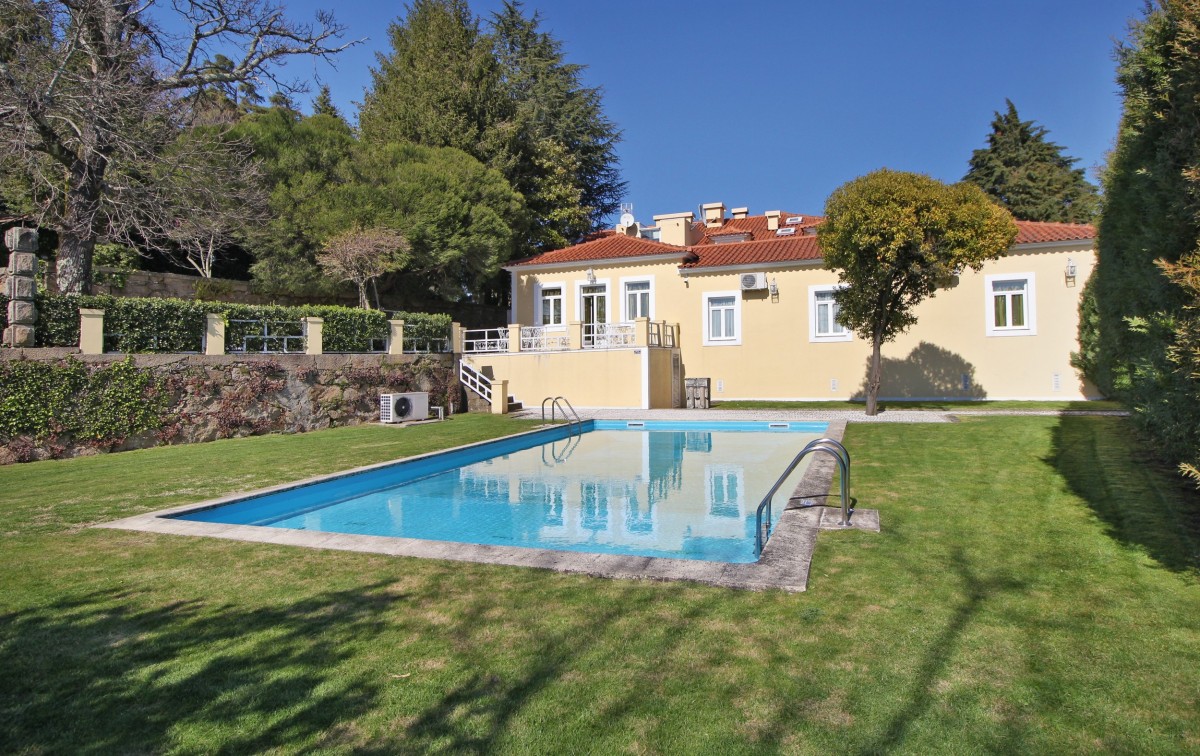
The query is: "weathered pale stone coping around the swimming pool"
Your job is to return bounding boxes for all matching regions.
[94,420,880,593]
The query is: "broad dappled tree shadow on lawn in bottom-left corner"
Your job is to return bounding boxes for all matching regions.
[0,583,406,752]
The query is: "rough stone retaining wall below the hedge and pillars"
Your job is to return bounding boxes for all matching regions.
[0,349,467,464]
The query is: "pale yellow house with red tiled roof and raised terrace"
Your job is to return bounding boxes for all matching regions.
[458,203,1099,412]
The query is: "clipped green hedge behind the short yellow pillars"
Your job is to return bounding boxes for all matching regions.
[37,294,450,353]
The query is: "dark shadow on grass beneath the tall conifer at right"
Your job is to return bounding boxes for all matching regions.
[1045,416,1200,572]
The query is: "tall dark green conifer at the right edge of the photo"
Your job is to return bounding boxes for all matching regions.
[1080,0,1200,475]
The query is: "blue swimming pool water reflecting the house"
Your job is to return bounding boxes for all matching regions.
[178,420,826,562]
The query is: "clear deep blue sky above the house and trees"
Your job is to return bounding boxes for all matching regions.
[194,0,1144,223]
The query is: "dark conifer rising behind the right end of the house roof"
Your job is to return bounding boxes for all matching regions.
[964,100,1099,223]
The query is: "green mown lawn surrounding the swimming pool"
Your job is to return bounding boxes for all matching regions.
[0,415,1200,754]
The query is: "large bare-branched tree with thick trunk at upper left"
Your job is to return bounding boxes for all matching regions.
[0,0,353,292]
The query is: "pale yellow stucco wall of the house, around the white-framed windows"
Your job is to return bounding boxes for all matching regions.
[505,242,1099,407]
